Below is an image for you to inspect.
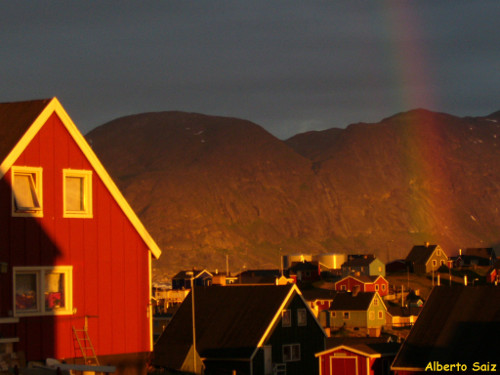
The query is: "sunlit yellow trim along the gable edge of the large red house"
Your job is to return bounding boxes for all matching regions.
[0,97,161,259]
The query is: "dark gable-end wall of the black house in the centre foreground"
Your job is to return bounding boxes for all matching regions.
[264,295,325,375]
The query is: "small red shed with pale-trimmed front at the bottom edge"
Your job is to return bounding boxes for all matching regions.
[316,343,399,375]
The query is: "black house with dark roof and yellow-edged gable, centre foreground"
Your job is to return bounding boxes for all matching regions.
[152,284,326,375]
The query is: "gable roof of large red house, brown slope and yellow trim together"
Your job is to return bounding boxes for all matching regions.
[0,98,161,258]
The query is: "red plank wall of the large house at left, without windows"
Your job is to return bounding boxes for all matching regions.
[0,114,150,360]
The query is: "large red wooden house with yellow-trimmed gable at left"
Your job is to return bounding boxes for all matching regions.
[0,98,160,372]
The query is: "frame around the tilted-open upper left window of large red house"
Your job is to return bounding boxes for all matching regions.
[11,166,43,217]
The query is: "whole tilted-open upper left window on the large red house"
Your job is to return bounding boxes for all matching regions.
[11,167,43,217]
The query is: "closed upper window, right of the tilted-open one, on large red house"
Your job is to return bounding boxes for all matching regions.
[63,169,92,218]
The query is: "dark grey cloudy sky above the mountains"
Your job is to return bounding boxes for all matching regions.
[0,0,500,139]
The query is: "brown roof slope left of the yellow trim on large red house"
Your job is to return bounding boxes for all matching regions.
[0,99,52,163]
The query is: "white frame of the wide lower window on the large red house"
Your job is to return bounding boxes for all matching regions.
[12,266,73,316]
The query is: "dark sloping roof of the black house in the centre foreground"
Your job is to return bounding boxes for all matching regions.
[153,285,294,369]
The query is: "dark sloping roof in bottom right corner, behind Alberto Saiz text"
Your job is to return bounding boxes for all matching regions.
[393,285,500,369]
